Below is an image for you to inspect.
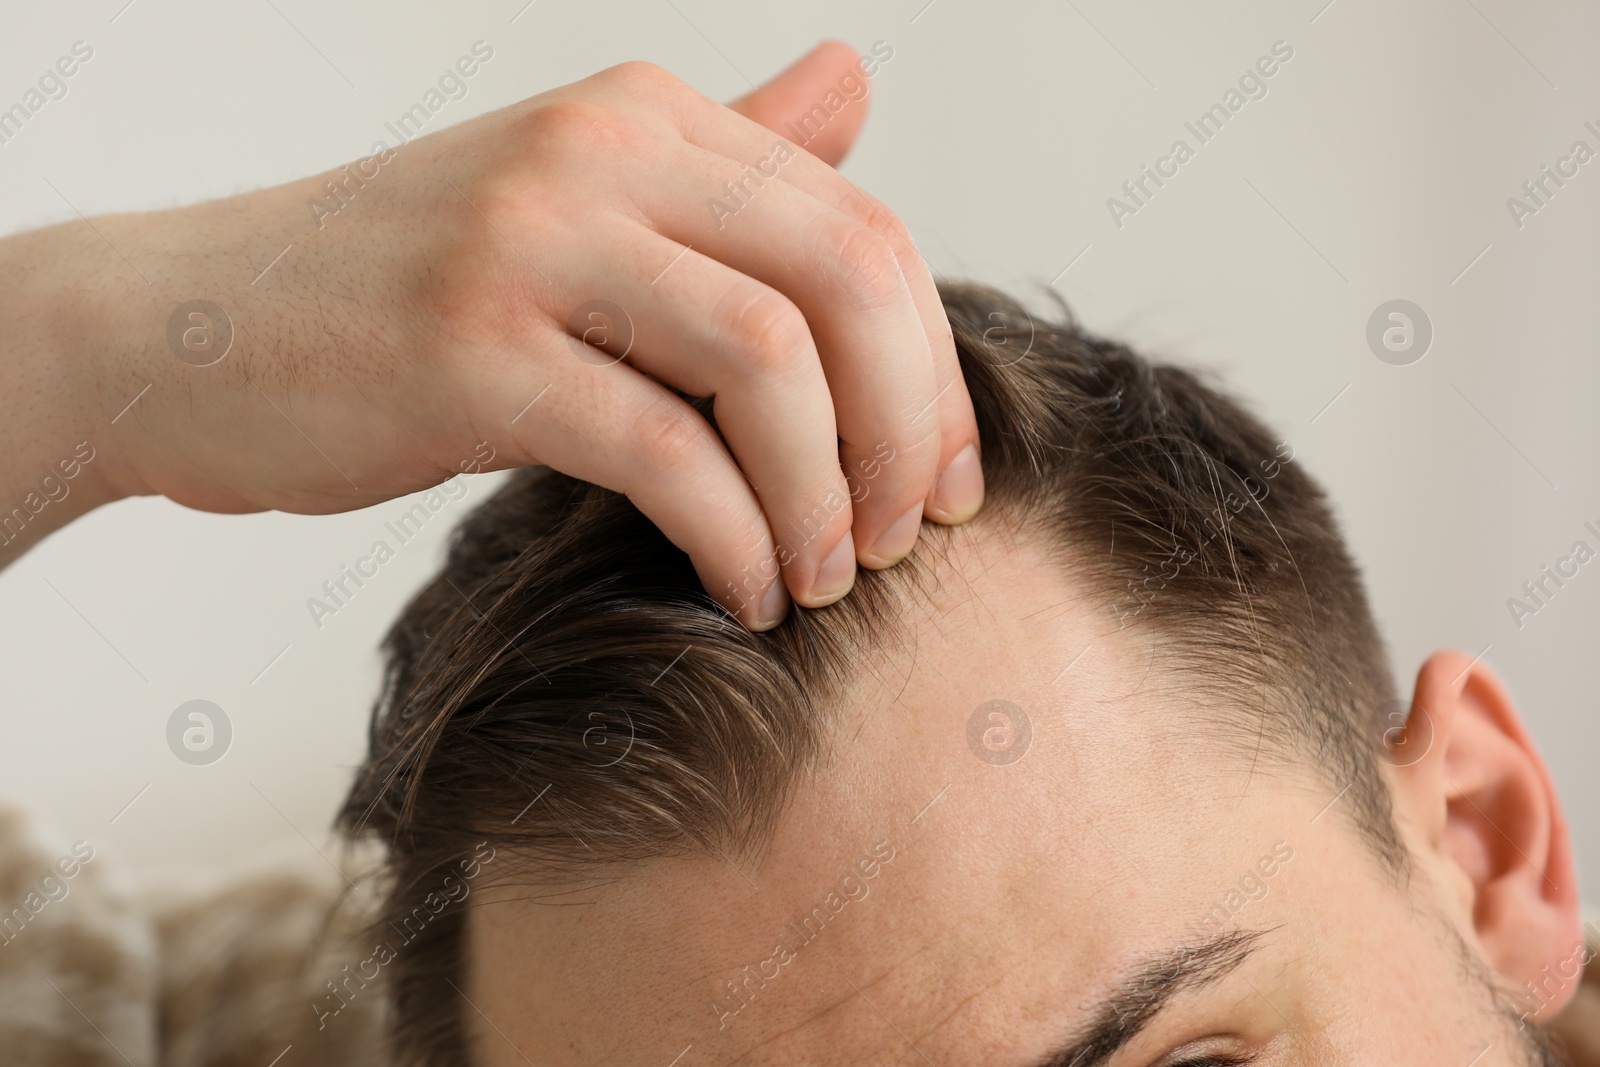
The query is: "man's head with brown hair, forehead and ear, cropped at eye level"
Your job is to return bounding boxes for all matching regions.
[344,279,1581,1067]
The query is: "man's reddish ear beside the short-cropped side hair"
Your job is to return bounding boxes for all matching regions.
[1390,651,1589,1019]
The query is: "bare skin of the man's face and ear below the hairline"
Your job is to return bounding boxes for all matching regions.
[462,514,1581,1067]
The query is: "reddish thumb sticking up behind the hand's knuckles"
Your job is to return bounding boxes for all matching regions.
[728,40,869,166]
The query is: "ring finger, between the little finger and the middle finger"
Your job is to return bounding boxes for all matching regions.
[573,221,856,608]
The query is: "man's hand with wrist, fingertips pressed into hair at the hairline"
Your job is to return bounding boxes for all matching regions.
[18,43,982,627]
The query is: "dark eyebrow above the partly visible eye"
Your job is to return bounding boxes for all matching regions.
[1035,929,1267,1067]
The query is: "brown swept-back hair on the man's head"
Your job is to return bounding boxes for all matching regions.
[339,285,1405,1064]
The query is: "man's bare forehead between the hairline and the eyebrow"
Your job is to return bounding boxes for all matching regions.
[470,533,1363,1065]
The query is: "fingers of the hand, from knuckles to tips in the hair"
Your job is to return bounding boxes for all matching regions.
[475,56,982,629]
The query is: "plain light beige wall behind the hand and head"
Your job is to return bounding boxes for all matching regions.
[0,0,1600,899]
